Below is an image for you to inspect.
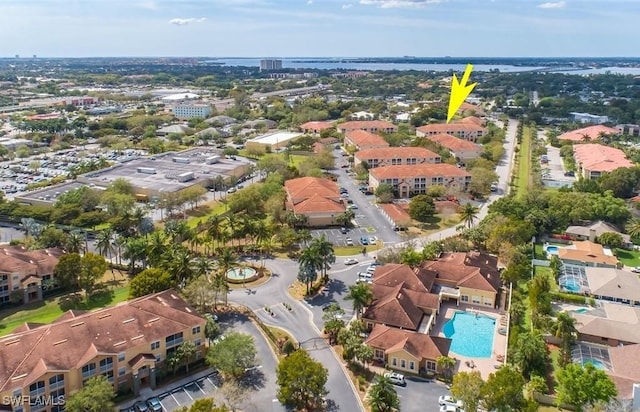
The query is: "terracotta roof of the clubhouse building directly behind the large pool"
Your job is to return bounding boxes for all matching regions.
[421,252,502,293]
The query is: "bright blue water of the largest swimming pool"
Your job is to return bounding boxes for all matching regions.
[442,312,496,358]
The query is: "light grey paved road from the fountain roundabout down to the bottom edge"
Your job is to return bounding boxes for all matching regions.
[229,260,363,412]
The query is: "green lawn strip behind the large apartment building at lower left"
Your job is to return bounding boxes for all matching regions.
[0,286,129,336]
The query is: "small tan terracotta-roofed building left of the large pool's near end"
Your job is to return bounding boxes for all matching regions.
[365,324,451,374]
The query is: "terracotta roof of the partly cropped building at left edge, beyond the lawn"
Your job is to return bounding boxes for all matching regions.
[0,246,64,276]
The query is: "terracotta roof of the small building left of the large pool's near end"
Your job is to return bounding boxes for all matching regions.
[365,325,451,360]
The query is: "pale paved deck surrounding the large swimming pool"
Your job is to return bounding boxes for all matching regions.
[431,302,507,379]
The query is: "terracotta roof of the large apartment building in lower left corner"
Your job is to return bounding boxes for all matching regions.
[0,290,205,392]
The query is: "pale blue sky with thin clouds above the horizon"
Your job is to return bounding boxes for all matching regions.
[0,0,640,57]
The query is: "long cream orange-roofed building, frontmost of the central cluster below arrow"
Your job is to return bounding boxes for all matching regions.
[369,163,471,198]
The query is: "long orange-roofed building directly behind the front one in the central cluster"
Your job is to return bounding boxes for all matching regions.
[353,147,442,168]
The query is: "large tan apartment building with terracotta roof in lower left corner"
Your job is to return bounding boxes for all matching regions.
[0,290,206,412]
